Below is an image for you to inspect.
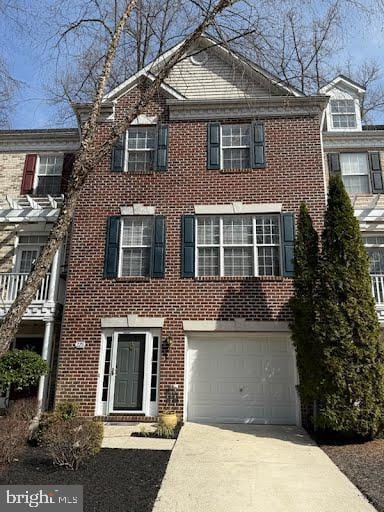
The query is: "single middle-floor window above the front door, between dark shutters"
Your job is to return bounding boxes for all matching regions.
[119,216,153,277]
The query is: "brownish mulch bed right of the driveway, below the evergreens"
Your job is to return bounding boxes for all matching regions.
[316,439,384,512]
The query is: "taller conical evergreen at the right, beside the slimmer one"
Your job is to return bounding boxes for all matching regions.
[314,177,384,438]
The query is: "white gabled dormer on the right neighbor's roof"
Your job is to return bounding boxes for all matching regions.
[319,75,365,132]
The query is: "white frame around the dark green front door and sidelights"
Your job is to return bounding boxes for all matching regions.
[95,329,161,416]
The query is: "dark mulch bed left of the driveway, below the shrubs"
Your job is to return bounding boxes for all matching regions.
[0,447,171,512]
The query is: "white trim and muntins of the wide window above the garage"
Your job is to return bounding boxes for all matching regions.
[195,214,283,279]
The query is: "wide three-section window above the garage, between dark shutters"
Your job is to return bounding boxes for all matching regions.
[196,215,280,277]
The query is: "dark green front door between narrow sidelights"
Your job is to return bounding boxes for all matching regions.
[113,334,145,411]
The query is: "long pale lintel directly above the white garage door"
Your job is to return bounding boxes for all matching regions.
[183,318,290,332]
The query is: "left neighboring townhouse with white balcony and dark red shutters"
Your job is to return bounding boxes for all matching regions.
[0,129,79,408]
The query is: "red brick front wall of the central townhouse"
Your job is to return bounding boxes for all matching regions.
[56,88,325,415]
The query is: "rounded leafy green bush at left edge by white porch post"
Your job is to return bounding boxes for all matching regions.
[0,349,49,392]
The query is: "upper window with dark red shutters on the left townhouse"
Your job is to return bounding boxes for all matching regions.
[35,155,63,196]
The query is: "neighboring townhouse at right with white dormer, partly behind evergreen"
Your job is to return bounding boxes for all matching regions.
[320,76,384,323]
